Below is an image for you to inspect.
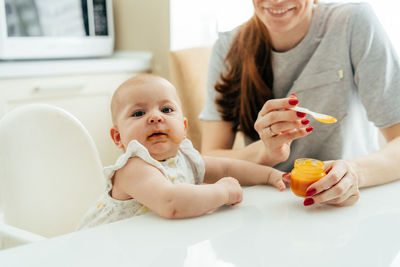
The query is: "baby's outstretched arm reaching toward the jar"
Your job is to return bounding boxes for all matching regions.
[204,156,286,191]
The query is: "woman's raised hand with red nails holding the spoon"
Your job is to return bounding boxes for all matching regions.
[254,94,313,166]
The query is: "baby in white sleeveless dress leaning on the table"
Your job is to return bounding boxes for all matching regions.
[79,74,285,228]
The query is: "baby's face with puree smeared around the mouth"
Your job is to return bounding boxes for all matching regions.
[114,80,187,160]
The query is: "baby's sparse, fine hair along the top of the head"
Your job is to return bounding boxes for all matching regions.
[111,73,181,125]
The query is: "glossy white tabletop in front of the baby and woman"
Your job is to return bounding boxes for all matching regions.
[0,182,400,267]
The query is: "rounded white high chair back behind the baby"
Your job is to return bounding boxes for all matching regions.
[0,104,104,240]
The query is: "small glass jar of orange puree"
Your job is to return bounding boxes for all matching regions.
[290,158,326,197]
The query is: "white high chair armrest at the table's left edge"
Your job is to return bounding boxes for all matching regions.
[0,222,47,249]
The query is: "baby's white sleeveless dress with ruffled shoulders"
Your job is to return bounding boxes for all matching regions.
[77,139,205,230]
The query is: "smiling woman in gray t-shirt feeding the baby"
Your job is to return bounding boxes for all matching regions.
[200,0,400,206]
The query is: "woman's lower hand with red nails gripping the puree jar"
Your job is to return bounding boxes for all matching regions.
[304,160,360,206]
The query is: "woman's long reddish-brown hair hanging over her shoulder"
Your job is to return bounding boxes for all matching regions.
[215,15,273,140]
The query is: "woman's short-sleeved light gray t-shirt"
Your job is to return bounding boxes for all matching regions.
[199,3,400,171]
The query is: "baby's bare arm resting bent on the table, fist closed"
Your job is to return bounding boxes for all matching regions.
[113,157,242,218]
